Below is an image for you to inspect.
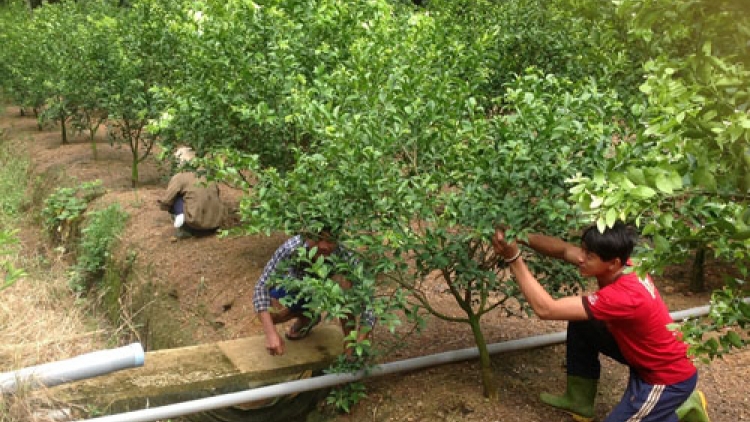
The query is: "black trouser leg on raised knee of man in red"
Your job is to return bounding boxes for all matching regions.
[565,320,628,379]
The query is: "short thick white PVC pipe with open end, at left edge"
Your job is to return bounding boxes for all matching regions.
[0,343,145,393]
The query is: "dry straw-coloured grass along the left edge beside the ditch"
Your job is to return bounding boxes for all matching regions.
[0,111,110,422]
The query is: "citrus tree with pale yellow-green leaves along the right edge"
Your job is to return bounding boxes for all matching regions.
[573,0,750,356]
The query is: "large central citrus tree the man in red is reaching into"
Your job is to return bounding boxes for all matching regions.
[195,2,636,396]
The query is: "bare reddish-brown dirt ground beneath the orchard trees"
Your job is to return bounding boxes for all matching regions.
[0,107,750,422]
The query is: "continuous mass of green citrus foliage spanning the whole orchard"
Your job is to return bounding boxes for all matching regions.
[0,0,750,404]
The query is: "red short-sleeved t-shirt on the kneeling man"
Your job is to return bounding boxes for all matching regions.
[583,273,696,385]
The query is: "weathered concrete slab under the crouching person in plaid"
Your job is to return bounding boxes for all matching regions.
[48,325,343,412]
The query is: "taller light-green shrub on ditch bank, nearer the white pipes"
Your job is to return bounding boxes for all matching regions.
[70,204,128,292]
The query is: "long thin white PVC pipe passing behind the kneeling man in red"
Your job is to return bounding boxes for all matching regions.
[77,304,724,422]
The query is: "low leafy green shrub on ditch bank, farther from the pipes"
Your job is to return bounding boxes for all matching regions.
[42,180,104,244]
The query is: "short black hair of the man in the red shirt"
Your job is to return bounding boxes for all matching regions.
[581,221,638,265]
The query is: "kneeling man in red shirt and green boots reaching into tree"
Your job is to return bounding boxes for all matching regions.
[492,222,709,422]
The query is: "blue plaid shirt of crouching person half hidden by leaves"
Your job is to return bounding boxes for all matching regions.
[253,235,375,327]
